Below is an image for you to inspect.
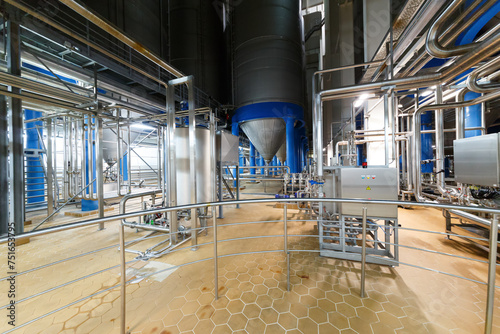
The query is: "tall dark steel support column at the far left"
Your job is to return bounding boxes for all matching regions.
[7,21,25,234]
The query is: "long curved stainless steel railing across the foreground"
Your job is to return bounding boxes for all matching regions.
[0,198,500,333]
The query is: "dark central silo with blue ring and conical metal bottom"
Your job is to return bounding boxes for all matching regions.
[233,0,304,172]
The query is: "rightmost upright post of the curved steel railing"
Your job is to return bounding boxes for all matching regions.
[484,214,498,334]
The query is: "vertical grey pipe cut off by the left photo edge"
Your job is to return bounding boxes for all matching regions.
[0,95,9,235]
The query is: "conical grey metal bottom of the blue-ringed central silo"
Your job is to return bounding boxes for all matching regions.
[240,118,286,163]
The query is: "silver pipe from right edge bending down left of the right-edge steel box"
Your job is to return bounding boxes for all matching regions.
[413,90,500,202]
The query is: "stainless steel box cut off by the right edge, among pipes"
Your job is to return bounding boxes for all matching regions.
[453,133,500,187]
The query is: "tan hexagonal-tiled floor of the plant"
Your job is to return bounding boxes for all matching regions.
[0,184,500,334]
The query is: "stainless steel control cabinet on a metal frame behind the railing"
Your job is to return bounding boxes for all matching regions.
[324,167,398,219]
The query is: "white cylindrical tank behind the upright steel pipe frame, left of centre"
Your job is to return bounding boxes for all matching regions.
[175,128,215,205]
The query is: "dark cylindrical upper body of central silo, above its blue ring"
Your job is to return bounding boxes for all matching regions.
[233,0,304,108]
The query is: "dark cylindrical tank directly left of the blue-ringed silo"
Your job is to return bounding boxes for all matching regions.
[169,0,226,103]
